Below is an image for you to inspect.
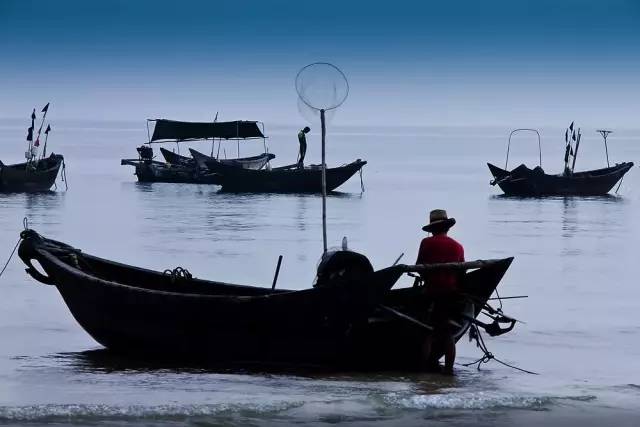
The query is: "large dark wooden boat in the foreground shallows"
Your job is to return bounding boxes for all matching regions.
[18,229,515,371]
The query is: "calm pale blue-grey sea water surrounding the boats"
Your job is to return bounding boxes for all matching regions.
[0,120,640,425]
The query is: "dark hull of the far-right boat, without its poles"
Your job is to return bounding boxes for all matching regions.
[487,162,633,197]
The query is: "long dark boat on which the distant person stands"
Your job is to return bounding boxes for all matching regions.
[206,159,367,193]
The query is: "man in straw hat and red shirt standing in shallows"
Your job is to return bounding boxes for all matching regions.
[416,209,464,374]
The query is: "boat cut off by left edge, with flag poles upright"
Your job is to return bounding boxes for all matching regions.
[0,104,64,193]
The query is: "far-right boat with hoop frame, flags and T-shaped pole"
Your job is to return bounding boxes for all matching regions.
[487,123,633,197]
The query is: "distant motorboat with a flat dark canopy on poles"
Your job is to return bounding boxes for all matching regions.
[120,119,275,184]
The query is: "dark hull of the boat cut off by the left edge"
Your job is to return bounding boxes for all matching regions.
[0,154,64,193]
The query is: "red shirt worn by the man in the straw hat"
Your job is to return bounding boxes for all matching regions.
[416,234,464,291]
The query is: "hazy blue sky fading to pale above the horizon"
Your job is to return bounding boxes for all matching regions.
[0,0,640,128]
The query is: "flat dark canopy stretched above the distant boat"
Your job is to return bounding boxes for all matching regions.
[148,119,265,143]
